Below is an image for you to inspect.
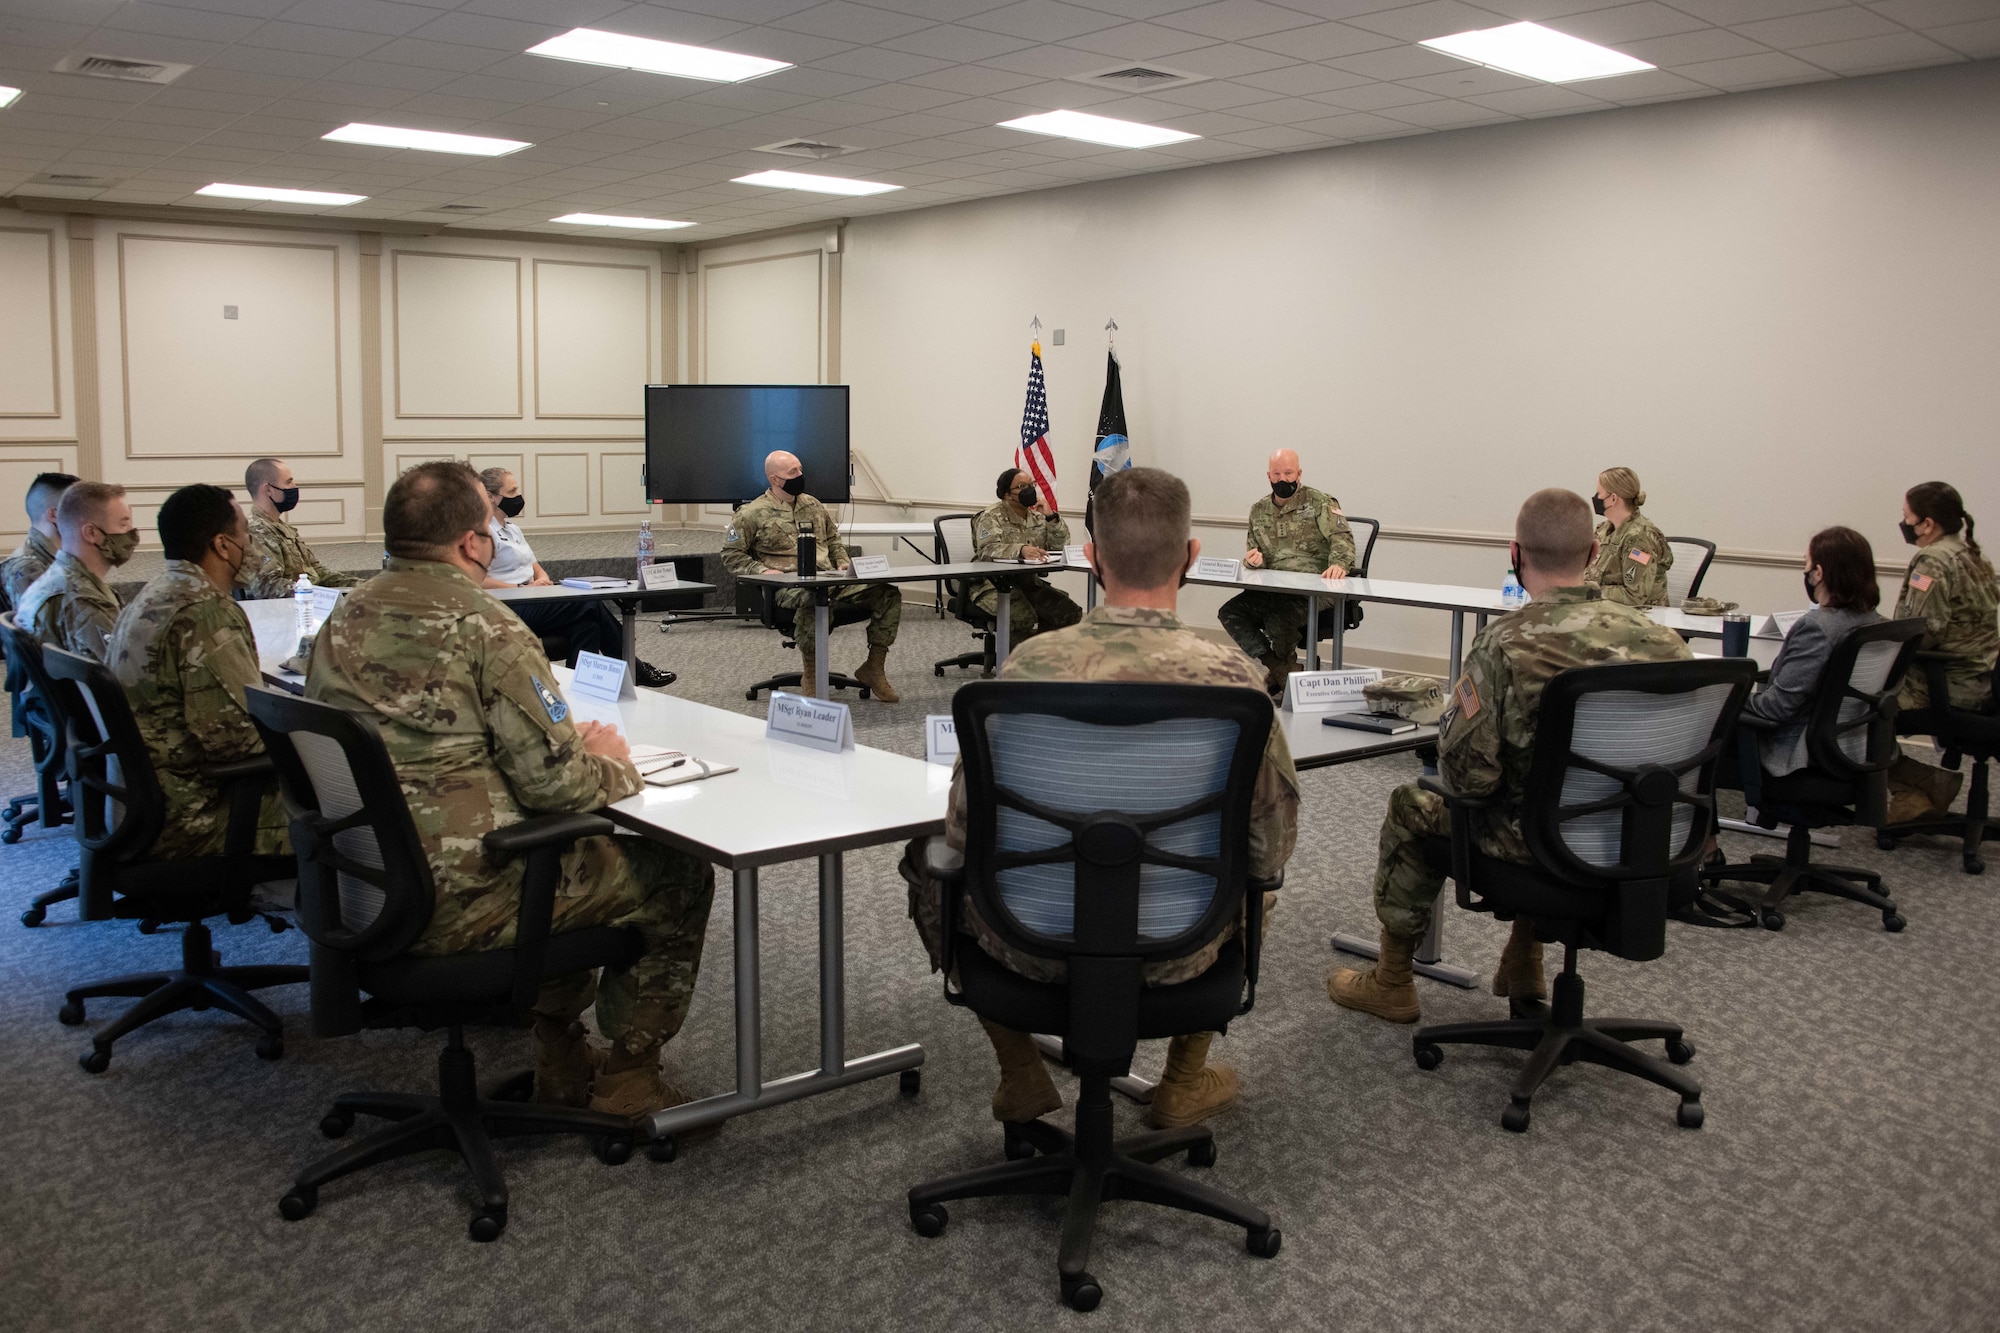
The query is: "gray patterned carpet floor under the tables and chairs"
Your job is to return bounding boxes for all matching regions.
[0,606,2000,1333]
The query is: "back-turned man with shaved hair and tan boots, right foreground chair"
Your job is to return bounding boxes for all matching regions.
[1326,488,1692,1023]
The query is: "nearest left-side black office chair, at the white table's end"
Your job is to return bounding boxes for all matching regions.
[250,689,642,1241]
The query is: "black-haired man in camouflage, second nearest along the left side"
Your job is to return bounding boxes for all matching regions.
[106,486,286,857]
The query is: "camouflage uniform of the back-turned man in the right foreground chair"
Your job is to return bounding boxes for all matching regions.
[1374,588,1692,937]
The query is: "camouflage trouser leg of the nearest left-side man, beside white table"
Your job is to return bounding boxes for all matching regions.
[534,837,716,1055]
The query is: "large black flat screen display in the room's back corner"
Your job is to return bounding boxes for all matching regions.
[646,384,848,504]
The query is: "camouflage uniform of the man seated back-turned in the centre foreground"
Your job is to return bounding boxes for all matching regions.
[904,606,1298,987]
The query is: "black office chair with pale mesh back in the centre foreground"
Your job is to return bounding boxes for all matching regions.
[910,681,1280,1309]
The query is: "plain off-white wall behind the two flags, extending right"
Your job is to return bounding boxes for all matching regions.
[842,62,2000,652]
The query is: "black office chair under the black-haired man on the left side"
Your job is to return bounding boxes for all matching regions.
[42,646,306,1073]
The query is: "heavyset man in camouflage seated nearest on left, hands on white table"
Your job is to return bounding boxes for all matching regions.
[306,462,714,1117]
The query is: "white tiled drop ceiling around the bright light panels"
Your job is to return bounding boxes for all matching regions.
[0,0,2000,242]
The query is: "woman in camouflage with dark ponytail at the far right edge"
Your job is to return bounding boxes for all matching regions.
[1890,472,2000,823]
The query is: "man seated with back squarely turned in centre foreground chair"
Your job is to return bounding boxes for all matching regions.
[904,468,1298,1129]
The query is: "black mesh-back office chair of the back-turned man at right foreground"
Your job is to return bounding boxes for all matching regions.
[1412,658,1756,1133]
